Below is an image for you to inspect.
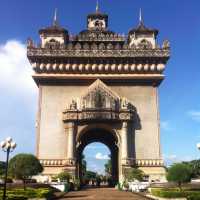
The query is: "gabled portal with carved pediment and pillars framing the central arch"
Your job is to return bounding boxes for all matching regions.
[63,80,136,181]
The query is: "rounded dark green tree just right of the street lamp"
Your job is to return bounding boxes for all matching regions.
[9,154,43,190]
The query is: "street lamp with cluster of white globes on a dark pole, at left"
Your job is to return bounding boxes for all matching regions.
[1,137,17,200]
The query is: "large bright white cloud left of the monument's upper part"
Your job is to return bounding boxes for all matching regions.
[0,40,37,96]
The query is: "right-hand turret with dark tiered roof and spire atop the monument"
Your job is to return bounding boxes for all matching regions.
[128,9,158,49]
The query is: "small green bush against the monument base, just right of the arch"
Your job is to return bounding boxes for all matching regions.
[125,168,145,181]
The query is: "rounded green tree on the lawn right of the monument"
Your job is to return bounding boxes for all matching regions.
[167,163,192,190]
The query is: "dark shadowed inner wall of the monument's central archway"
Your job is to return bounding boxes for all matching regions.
[77,128,119,185]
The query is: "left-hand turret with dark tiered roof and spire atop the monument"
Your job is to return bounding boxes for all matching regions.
[39,9,69,49]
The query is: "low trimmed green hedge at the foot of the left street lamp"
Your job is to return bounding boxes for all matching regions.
[0,188,53,200]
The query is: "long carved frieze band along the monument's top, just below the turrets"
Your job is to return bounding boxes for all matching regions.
[27,46,170,58]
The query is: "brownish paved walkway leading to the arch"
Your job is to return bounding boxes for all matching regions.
[61,188,148,200]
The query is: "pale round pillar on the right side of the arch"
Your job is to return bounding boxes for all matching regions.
[121,122,129,165]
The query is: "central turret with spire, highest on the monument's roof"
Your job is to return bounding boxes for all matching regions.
[87,1,108,30]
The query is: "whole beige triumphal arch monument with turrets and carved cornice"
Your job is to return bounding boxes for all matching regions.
[27,7,170,181]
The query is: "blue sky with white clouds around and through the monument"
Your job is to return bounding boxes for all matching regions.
[0,0,200,172]
